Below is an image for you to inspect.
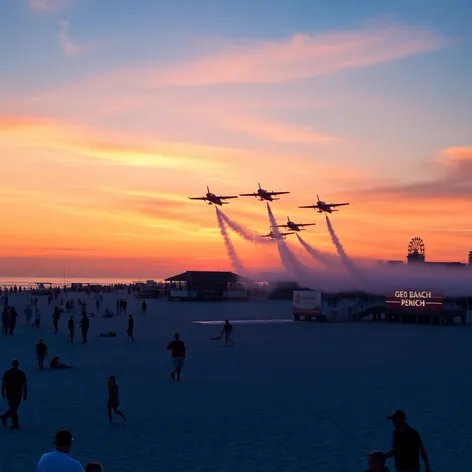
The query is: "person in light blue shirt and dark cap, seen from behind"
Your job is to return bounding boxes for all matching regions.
[36,430,84,472]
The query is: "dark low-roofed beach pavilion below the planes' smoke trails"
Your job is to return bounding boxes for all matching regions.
[165,270,252,300]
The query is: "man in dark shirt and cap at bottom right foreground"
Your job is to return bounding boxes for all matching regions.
[385,410,431,472]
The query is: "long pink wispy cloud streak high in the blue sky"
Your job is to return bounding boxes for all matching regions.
[146,22,451,86]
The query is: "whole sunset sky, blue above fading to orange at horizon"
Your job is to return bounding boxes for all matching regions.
[0,0,472,279]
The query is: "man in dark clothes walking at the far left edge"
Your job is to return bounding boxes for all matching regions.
[0,359,28,429]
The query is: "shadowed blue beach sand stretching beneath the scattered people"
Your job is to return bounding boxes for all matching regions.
[0,292,472,472]
